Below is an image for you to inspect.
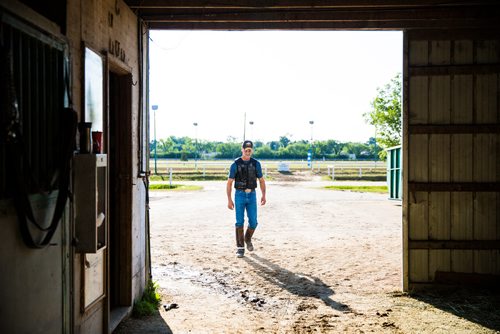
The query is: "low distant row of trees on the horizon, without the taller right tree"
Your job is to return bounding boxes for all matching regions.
[150,136,382,160]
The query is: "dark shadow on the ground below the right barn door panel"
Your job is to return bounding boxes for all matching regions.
[410,287,500,331]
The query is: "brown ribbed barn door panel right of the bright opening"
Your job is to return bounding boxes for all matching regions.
[404,31,500,289]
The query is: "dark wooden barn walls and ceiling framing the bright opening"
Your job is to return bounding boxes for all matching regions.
[0,0,500,333]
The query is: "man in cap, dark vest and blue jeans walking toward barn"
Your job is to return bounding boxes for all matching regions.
[226,140,266,257]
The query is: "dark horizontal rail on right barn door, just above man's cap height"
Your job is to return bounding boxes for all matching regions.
[409,124,500,135]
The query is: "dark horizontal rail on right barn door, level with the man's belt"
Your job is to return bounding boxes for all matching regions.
[408,182,500,192]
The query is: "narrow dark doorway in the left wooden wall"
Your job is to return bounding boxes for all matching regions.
[107,61,133,328]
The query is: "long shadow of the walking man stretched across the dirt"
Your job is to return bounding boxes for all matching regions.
[244,254,351,312]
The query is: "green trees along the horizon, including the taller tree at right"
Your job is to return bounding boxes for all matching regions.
[150,73,401,160]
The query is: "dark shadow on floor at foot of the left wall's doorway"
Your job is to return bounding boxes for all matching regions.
[113,311,173,334]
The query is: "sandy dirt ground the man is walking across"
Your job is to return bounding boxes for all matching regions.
[115,177,500,334]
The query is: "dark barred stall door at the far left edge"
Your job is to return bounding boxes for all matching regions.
[0,11,70,333]
